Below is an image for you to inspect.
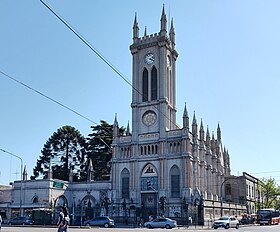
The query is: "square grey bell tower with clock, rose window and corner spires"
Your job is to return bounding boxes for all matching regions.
[130,6,178,141]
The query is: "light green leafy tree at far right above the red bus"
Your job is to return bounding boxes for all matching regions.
[259,177,280,208]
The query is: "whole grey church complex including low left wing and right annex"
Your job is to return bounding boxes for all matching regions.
[0,7,249,225]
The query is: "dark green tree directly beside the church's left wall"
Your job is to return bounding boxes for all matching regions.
[87,120,124,180]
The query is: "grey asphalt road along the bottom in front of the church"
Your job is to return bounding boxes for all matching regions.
[1,225,280,232]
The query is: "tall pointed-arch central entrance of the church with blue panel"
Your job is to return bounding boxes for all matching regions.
[141,164,158,221]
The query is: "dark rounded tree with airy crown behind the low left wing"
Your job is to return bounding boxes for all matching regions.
[31,126,87,181]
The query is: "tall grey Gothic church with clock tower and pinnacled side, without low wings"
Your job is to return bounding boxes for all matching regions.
[111,7,244,225]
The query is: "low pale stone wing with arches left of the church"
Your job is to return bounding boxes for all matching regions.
[0,179,111,224]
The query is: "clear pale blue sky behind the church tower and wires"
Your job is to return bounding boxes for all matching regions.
[0,0,280,184]
